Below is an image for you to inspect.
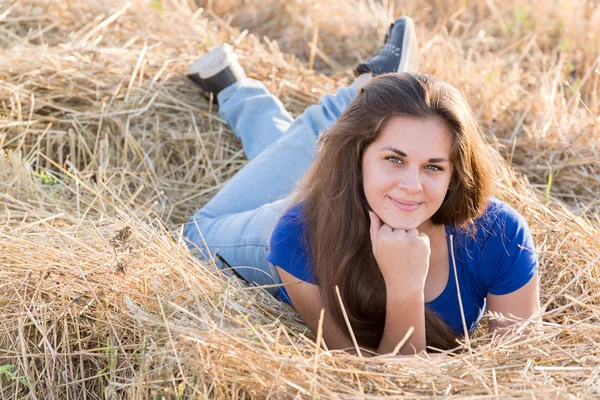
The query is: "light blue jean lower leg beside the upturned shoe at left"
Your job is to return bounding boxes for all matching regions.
[217,78,294,160]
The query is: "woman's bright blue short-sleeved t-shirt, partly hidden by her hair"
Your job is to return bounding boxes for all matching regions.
[267,197,538,334]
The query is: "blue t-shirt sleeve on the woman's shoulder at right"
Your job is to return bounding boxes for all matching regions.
[486,204,538,295]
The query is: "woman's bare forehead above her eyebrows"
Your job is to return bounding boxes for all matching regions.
[372,116,453,158]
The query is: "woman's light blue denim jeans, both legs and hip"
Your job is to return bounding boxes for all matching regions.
[184,79,356,293]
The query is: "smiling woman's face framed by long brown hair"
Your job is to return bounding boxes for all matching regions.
[362,117,453,230]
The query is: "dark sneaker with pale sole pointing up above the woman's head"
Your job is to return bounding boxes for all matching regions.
[356,16,419,75]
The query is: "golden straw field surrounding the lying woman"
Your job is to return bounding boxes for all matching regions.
[0,0,600,399]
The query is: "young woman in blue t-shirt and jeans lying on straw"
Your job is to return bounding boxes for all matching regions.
[185,17,539,354]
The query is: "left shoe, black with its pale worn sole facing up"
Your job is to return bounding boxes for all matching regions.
[187,43,246,101]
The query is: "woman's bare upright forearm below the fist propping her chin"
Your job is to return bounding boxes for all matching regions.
[377,290,425,354]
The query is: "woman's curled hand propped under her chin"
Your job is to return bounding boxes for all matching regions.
[369,211,431,294]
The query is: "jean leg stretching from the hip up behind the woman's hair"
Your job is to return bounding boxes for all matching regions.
[184,83,356,285]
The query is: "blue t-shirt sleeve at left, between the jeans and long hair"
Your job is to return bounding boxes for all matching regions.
[267,205,315,284]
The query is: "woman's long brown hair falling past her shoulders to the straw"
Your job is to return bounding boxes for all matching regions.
[292,73,491,349]
